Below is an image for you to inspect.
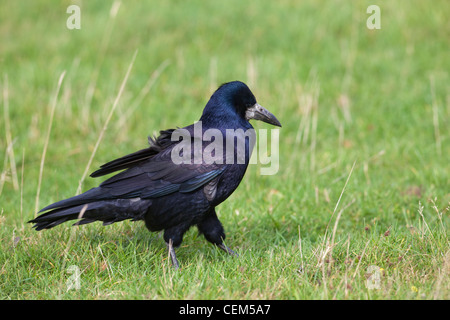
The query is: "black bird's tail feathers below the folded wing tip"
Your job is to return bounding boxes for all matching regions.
[28,188,151,230]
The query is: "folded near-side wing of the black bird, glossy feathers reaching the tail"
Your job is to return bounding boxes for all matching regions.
[40,139,228,212]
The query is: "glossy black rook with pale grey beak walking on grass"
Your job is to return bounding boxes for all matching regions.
[29,81,281,268]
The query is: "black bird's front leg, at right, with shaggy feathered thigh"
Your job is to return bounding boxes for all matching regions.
[197,208,239,257]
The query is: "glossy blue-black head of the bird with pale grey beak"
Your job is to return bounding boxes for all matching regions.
[200,81,281,127]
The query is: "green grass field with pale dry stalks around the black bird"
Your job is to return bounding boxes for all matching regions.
[0,0,450,299]
